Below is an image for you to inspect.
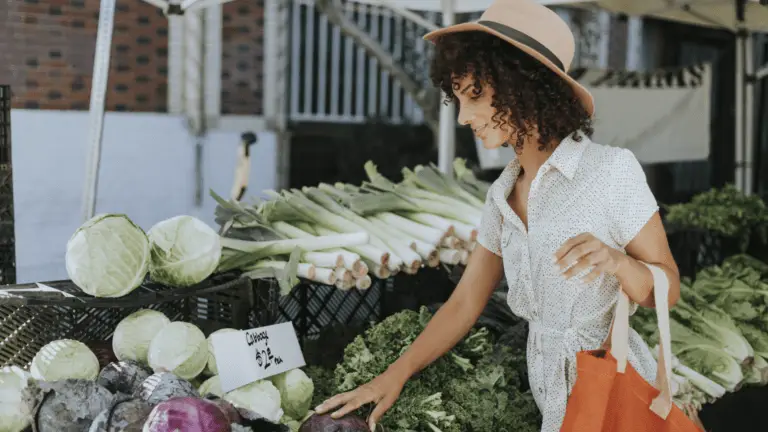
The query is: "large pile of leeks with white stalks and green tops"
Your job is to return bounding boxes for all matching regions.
[212,159,489,293]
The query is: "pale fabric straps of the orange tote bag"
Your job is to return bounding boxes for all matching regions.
[611,263,672,419]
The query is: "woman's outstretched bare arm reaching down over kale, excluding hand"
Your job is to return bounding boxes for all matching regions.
[390,247,503,380]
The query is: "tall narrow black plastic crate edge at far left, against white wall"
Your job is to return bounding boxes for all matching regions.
[0,85,16,285]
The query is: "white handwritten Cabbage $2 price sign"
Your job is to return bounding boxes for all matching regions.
[211,322,306,393]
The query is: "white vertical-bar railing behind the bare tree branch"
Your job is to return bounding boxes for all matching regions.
[289,0,450,123]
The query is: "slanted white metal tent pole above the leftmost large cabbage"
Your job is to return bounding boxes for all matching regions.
[83,0,116,220]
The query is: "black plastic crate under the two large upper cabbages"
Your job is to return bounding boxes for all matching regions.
[0,273,278,367]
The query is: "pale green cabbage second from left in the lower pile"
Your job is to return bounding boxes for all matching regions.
[29,339,99,381]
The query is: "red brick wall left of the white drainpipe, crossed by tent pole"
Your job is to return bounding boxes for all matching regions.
[0,0,168,111]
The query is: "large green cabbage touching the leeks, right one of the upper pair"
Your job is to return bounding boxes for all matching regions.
[148,216,221,286]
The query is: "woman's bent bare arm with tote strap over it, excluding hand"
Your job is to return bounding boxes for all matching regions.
[615,213,680,307]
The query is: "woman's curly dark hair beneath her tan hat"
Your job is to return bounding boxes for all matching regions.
[430,31,594,153]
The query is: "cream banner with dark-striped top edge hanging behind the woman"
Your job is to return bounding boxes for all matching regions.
[476,64,711,169]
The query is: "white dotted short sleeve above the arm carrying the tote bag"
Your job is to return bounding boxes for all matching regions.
[608,149,659,247]
